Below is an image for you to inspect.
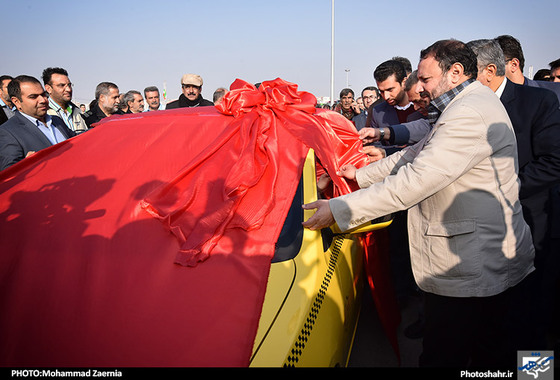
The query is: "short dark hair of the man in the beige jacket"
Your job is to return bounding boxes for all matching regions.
[420,39,478,78]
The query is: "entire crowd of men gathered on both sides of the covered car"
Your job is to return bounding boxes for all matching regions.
[0,35,560,368]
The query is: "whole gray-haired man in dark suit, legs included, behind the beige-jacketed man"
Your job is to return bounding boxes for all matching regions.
[469,40,560,354]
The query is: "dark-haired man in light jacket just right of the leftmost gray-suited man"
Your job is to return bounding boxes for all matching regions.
[43,67,88,134]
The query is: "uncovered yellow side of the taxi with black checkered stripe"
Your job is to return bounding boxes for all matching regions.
[250,150,391,367]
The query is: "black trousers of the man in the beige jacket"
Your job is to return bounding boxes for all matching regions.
[419,290,516,369]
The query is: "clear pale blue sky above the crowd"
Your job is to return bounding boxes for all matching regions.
[5,0,560,103]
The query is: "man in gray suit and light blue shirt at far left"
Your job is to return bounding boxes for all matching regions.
[0,75,75,170]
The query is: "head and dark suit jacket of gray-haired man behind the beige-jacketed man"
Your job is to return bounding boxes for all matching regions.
[468,40,560,262]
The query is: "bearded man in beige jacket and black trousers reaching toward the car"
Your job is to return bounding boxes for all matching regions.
[303,40,534,368]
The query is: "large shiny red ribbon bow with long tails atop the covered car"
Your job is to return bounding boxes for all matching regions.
[142,78,367,266]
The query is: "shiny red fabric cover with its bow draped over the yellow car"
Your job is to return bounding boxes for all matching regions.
[0,79,388,367]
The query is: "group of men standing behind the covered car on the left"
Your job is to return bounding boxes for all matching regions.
[0,71,220,170]
